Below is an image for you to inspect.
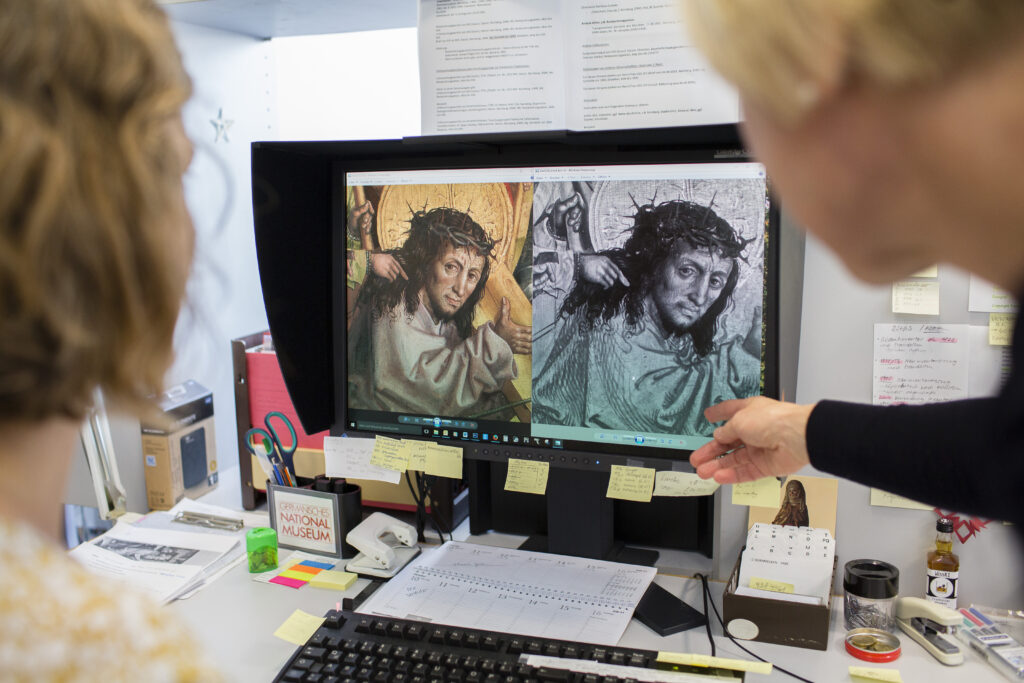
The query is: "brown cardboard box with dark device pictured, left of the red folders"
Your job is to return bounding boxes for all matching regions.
[141,380,217,510]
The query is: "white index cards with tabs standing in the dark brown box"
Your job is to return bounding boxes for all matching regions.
[735,523,836,604]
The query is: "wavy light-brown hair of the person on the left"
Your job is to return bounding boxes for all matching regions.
[0,0,193,421]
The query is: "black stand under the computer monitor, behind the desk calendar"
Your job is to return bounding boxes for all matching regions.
[519,467,658,566]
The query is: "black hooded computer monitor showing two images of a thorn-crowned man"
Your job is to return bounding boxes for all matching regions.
[254,127,778,561]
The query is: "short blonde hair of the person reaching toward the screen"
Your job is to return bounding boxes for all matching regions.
[681,0,1024,123]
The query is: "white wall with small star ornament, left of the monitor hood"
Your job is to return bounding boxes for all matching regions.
[167,24,276,485]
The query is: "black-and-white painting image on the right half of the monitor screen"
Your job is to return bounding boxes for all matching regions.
[532,178,767,435]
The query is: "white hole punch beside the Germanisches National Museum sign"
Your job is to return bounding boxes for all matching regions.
[345,512,420,579]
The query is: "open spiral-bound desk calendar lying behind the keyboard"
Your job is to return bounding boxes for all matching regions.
[358,542,656,645]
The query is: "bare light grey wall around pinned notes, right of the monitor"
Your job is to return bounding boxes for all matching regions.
[797,238,1024,605]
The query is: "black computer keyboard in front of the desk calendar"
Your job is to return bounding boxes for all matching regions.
[274,609,741,683]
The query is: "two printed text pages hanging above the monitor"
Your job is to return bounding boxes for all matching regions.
[419,0,739,135]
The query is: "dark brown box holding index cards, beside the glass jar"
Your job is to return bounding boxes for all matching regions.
[722,551,839,650]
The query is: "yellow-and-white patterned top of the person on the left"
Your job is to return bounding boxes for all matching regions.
[0,519,223,683]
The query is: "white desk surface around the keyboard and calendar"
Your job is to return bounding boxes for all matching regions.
[174,473,1005,683]
